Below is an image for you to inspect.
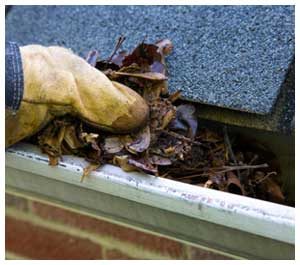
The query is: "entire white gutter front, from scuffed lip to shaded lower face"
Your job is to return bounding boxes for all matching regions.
[5,143,295,259]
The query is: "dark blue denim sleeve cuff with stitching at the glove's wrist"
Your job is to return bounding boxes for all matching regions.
[5,42,24,112]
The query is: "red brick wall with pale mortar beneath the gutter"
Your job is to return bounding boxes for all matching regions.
[5,191,228,259]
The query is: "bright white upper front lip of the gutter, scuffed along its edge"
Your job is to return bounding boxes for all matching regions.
[6,143,295,244]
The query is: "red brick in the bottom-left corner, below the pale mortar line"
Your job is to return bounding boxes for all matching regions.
[5,217,102,259]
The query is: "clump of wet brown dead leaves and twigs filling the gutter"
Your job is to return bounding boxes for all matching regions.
[33,37,285,203]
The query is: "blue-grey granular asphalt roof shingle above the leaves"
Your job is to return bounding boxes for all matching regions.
[6,6,295,114]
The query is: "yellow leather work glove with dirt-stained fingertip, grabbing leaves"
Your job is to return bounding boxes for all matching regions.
[5,45,149,147]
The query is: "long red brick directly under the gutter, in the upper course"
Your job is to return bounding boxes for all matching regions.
[33,202,184,258]
